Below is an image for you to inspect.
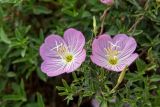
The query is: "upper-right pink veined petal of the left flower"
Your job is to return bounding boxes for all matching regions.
[64,28,85,53]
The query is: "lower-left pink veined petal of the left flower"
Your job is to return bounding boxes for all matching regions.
[41,58,66,77]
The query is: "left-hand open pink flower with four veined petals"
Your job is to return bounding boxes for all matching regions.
[40,28,86,77]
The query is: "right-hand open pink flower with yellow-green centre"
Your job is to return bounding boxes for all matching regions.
[91,34,138,72]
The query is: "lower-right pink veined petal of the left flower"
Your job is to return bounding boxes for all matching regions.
[65,49,86,73]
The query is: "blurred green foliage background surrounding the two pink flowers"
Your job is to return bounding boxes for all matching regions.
[0,0,160,107]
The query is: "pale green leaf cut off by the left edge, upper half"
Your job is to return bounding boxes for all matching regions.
[0,27,11,44]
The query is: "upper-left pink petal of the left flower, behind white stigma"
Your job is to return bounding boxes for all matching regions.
[39,35,66,60]
